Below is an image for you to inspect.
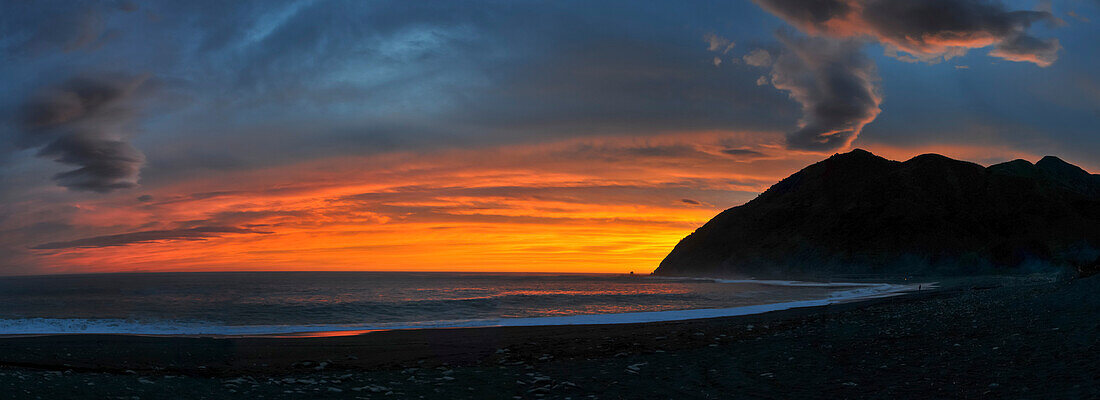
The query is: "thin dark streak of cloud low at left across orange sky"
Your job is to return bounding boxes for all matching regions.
[31,226,270,249]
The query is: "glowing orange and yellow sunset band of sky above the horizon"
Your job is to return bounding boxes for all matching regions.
[15,132,1064,273]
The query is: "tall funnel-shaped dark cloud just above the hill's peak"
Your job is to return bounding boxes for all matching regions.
[770,34,882,152]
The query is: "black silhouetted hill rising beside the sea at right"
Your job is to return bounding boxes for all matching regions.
[653,149,1100,278]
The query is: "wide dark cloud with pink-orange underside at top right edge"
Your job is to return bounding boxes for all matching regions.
[755,0,1060,67]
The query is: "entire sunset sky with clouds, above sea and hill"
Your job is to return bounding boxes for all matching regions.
[0,0,1100,275]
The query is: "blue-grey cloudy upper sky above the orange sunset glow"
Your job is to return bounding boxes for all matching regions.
[0,0,1100,274]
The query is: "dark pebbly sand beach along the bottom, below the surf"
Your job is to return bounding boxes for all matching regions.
[0,277,1100,399]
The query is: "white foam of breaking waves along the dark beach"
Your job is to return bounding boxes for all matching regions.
[0,279,935,336]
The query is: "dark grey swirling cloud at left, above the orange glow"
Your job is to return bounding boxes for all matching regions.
[18,76,146,192]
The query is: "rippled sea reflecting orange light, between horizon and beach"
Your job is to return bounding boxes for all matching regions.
[0,271,908,335]
